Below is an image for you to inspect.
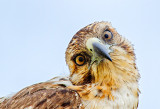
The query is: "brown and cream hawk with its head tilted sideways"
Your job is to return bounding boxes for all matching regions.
[0,21,140,109]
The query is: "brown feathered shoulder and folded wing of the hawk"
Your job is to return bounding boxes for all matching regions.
[0,77,81,109]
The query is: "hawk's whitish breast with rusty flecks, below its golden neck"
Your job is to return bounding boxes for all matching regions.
[80,86,138,109]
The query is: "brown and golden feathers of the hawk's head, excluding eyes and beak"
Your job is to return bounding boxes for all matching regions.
[66,22,139,87]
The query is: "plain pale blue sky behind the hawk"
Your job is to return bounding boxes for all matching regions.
[0,0,160,109]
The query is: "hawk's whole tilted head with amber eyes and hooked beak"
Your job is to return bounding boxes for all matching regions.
[66,22,139,88]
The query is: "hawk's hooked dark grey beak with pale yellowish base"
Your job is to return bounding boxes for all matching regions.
[86,38,112,64]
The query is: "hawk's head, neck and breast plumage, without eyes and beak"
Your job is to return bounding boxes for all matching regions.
[66,22,140,109]
